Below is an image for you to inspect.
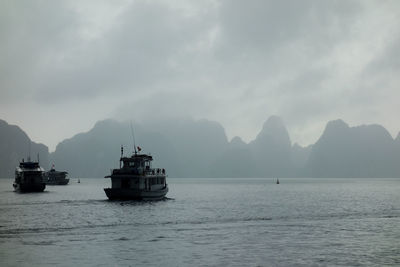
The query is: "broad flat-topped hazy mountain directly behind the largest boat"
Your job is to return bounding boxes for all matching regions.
[51,120,227,177]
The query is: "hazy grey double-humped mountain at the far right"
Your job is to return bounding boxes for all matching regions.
[306,120,399,177]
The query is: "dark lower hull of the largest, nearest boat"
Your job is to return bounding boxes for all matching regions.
[104,187,168,200]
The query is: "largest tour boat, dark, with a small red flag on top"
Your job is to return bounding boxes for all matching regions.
[104,147,168,200]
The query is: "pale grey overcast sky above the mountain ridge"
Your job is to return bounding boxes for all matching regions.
[0,0,400,150]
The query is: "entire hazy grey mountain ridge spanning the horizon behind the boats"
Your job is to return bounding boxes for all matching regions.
[0,116,400,177]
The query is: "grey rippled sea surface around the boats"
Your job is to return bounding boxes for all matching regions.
[0,178,400,266]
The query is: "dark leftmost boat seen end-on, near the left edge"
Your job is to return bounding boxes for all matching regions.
[13,157,46,193]
